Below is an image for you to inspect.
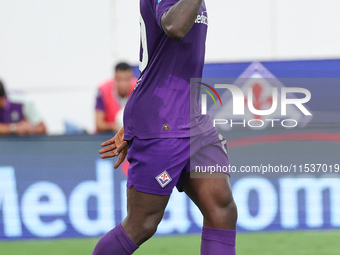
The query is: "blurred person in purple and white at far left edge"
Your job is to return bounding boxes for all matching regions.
[0,81,46,135]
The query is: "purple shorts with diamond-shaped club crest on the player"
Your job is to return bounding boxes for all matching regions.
[127,128,229,195]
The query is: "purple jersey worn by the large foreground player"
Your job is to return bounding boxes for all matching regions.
[124,0,213,140]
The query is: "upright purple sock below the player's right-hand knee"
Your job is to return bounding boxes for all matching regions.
[201,227,236,255]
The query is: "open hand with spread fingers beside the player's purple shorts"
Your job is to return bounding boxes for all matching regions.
[99,127,128,169]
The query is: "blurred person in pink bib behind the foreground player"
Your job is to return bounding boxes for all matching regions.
[96,62,137,132]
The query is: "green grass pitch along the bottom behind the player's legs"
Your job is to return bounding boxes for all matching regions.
[0,231,340,255]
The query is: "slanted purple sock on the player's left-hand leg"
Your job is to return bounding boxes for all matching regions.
[92,224,139,255]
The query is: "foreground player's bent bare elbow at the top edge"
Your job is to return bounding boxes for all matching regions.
[161,0,202,41]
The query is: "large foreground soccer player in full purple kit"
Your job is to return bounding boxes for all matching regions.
[93,0,237,255]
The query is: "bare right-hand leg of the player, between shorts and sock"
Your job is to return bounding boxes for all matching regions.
[183,173,237,229]
